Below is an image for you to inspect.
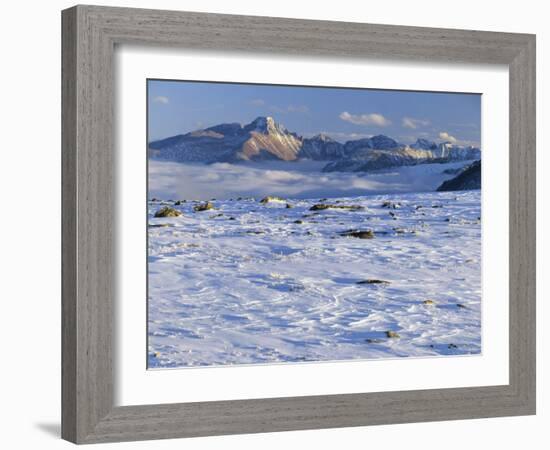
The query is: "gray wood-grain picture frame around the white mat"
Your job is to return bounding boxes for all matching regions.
[62,6,535,443]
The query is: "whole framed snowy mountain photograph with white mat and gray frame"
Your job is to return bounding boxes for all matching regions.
[62,6,535,443]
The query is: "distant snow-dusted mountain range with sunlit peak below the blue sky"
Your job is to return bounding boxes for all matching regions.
[149,117,481,172]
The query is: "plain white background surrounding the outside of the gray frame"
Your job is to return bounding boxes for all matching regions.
[0,0,550,450]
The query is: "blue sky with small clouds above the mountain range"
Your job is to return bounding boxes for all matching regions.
[147,80,481,146]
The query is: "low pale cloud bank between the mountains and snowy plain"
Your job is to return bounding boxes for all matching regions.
[149,160,466,200]
